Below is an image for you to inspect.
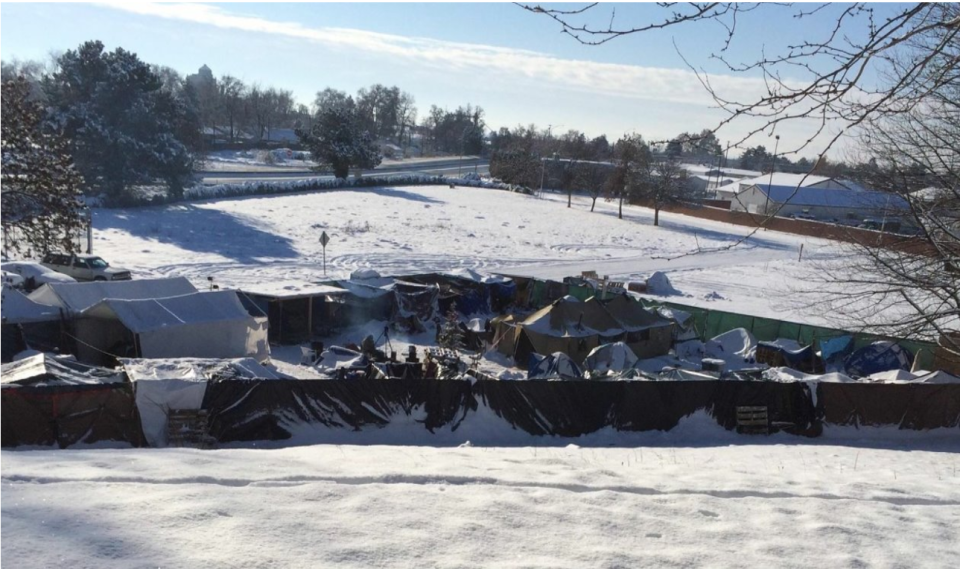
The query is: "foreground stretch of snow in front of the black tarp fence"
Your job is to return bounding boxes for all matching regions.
[2,435,960,568]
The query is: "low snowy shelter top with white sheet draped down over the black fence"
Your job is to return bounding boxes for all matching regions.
[121,358,279,447]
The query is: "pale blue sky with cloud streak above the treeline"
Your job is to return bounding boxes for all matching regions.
[0,1,900,156]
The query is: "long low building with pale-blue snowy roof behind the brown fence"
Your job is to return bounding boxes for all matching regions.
[730,184,909,221]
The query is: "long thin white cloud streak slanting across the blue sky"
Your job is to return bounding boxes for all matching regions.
[102,1,764,106]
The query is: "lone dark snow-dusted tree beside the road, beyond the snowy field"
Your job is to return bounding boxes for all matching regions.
[296,97,381,178]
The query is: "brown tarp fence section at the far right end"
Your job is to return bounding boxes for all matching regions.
[817,383,960,431]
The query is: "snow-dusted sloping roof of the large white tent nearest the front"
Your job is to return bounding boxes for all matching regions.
[83,290,251,334]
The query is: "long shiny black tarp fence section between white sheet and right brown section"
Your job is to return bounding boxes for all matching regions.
[203,379,816,443]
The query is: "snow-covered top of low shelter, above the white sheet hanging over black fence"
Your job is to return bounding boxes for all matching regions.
[120,358,280,381]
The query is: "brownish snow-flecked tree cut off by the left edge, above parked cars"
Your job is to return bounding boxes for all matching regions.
[0,76,83,254]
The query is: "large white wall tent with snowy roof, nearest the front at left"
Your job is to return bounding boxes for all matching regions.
[75,291,270,362]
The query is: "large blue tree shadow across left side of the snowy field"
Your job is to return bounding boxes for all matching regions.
[93,204,299,263]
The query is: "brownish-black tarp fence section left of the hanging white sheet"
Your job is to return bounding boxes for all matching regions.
[0,383,143,448]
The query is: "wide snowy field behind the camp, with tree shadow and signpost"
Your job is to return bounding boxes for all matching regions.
[88,186,838,323]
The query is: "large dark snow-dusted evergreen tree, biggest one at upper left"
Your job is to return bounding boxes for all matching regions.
[44,41,200,199]
